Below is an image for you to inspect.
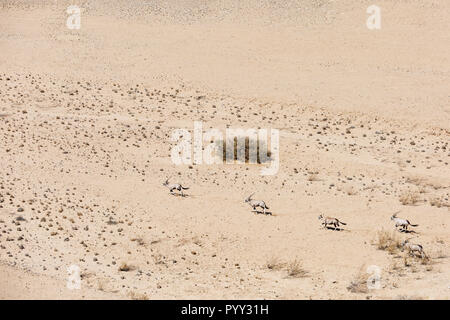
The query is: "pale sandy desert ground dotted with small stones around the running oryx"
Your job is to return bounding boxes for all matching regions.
[0,0,450,299]
